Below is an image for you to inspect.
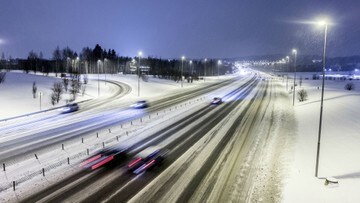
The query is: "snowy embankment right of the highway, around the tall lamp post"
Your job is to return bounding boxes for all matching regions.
[283,73,360,202]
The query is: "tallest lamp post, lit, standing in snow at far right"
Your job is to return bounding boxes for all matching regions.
[315,21,328,177]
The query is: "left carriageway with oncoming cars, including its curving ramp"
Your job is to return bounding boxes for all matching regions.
[0,75,240,164]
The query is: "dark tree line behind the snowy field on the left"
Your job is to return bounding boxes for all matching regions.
[0,44,231,80]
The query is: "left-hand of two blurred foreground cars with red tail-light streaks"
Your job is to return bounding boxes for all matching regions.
[80,146,127,170]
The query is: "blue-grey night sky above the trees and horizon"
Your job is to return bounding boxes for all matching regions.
[0,0,360,58]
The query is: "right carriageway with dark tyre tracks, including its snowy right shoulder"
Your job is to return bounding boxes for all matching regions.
[9,72,290,202]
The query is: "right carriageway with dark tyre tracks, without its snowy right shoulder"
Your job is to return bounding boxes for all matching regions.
[11,72,286,202]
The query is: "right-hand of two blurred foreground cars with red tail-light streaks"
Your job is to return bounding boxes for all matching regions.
[127,146,167,174]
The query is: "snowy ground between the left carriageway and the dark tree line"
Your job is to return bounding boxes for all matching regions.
[0,71,224,120]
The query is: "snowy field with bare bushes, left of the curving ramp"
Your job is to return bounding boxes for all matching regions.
[0,71,96,119]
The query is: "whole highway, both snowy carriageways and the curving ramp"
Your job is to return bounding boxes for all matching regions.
[0,72,288,202]
